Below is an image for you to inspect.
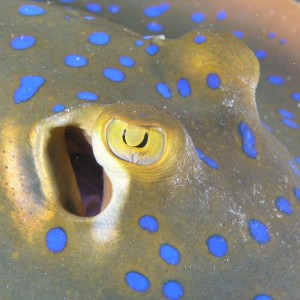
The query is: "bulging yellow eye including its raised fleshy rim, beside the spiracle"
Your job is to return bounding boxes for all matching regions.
[92,102,187,185]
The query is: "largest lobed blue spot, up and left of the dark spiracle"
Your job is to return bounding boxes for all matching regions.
[14,76,45,104]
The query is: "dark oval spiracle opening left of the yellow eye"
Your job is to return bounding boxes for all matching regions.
[47,125,112,217]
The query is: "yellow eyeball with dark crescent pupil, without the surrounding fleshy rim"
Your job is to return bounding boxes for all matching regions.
[106,120,166,165]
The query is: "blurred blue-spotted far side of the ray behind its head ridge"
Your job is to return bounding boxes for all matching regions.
[52,0,300,157]
